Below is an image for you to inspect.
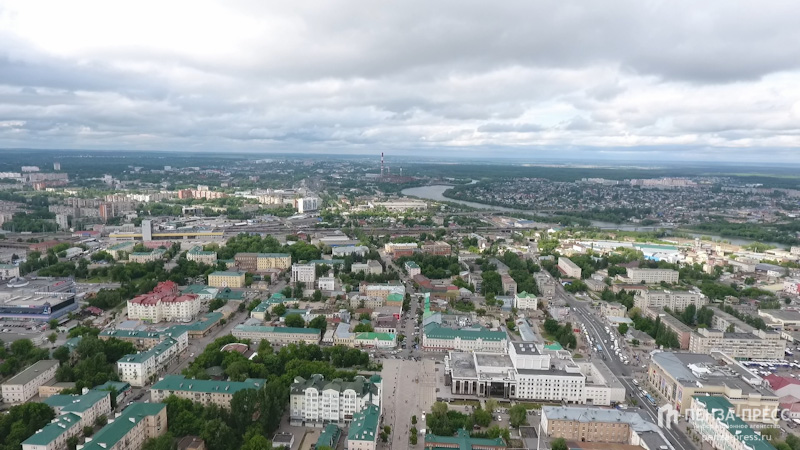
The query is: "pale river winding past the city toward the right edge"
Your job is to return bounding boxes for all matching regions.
[402,180,786,248]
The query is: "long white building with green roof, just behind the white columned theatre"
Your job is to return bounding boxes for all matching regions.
[422,323,508,353]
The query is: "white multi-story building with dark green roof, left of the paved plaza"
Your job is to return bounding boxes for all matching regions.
[289,375,382,427]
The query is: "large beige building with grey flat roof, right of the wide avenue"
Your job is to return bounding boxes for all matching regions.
[647,352,779,423]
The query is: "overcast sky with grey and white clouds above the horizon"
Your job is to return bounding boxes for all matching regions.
[0,0,800,160]
